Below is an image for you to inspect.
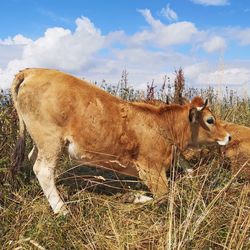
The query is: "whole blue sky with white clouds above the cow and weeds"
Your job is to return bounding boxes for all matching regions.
[0,0,250,95]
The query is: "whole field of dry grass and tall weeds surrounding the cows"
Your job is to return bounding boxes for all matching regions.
[0,79,250,250]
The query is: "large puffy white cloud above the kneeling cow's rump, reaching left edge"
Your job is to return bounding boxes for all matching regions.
[0,17,105,88]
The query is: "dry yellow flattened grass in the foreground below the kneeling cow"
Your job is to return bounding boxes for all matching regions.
[0,165,250,249]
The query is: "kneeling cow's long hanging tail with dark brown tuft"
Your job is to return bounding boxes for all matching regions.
[10,71,26,177]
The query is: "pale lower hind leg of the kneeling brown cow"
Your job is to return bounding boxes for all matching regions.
[33,150,67,214]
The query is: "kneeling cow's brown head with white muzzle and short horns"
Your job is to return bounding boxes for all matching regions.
[189,97,231,145]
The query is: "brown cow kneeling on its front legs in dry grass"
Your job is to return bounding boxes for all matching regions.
[11,68,231,214]
